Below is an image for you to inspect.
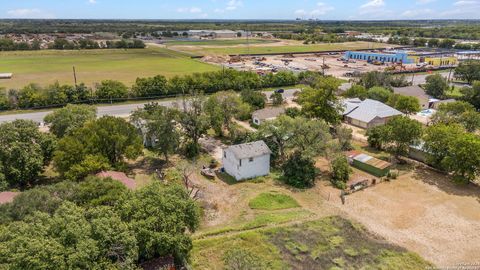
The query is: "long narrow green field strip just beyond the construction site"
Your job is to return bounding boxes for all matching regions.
[172,41,391,55]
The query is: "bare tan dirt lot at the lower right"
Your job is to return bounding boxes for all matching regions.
[326,168,480,267]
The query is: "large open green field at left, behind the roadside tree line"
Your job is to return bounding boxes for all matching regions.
[0,48,218,88]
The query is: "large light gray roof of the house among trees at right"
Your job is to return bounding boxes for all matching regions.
[343,99,403,123]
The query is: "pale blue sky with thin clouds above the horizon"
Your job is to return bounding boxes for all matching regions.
[0,0,480,20]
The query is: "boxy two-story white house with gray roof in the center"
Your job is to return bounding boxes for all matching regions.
[222,141,272,181]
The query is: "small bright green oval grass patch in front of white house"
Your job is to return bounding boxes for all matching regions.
[248,193,300,210]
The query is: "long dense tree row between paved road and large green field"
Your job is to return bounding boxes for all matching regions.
[0,69,303,110]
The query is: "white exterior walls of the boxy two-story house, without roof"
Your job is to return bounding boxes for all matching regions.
[222,151,270,181]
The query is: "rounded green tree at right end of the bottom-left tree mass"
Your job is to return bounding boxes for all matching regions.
[119,183,199,260]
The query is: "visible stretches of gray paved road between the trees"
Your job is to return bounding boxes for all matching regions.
[0,89,300,123]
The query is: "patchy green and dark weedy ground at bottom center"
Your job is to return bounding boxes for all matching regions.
[192,217,432,269]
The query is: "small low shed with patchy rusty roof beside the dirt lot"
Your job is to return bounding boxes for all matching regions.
[347,151,392,177]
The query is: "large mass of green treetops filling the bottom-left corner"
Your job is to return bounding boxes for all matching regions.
[0,181,199,269]
